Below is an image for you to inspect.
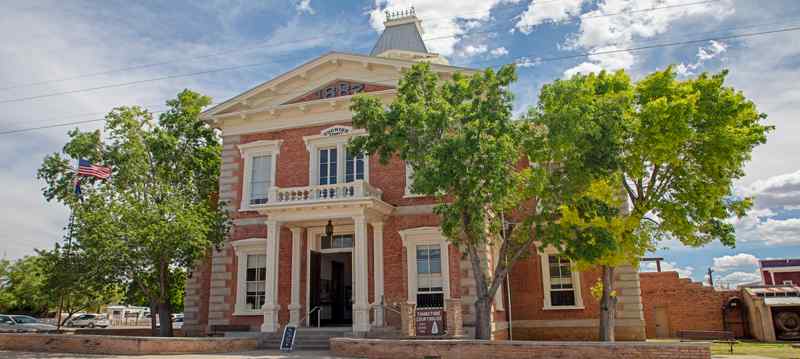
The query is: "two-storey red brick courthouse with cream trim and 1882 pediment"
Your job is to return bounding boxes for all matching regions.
[184,12,644,340]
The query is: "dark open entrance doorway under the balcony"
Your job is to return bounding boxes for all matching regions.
[309,251,353,326]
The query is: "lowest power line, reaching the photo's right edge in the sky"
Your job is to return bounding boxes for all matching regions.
[6,26,800,135]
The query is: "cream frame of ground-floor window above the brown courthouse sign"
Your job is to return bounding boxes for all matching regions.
[399,227,450,304]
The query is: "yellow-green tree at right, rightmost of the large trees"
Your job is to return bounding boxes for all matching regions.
[528,67,773,341]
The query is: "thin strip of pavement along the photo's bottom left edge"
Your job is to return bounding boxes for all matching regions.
[0,350,352,359]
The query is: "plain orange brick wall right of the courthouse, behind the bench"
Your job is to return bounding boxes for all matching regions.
[639,272,741,338]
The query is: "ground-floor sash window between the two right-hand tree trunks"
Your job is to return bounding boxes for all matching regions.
[542,254,583,309]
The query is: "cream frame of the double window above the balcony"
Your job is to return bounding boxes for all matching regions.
[303,125,369,186]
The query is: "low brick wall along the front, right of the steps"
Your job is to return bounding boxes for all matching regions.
[331,338,711,359]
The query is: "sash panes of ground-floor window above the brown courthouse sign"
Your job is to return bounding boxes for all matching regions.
[417,244,444,308]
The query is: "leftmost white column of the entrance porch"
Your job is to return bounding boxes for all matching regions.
[261,220,281,333]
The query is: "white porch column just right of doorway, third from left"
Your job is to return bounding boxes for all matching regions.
[353,216,370,332]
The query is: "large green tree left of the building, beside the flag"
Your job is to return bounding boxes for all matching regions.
[38,90,229,336]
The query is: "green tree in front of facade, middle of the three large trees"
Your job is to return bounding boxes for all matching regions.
[350,63,612,339]
